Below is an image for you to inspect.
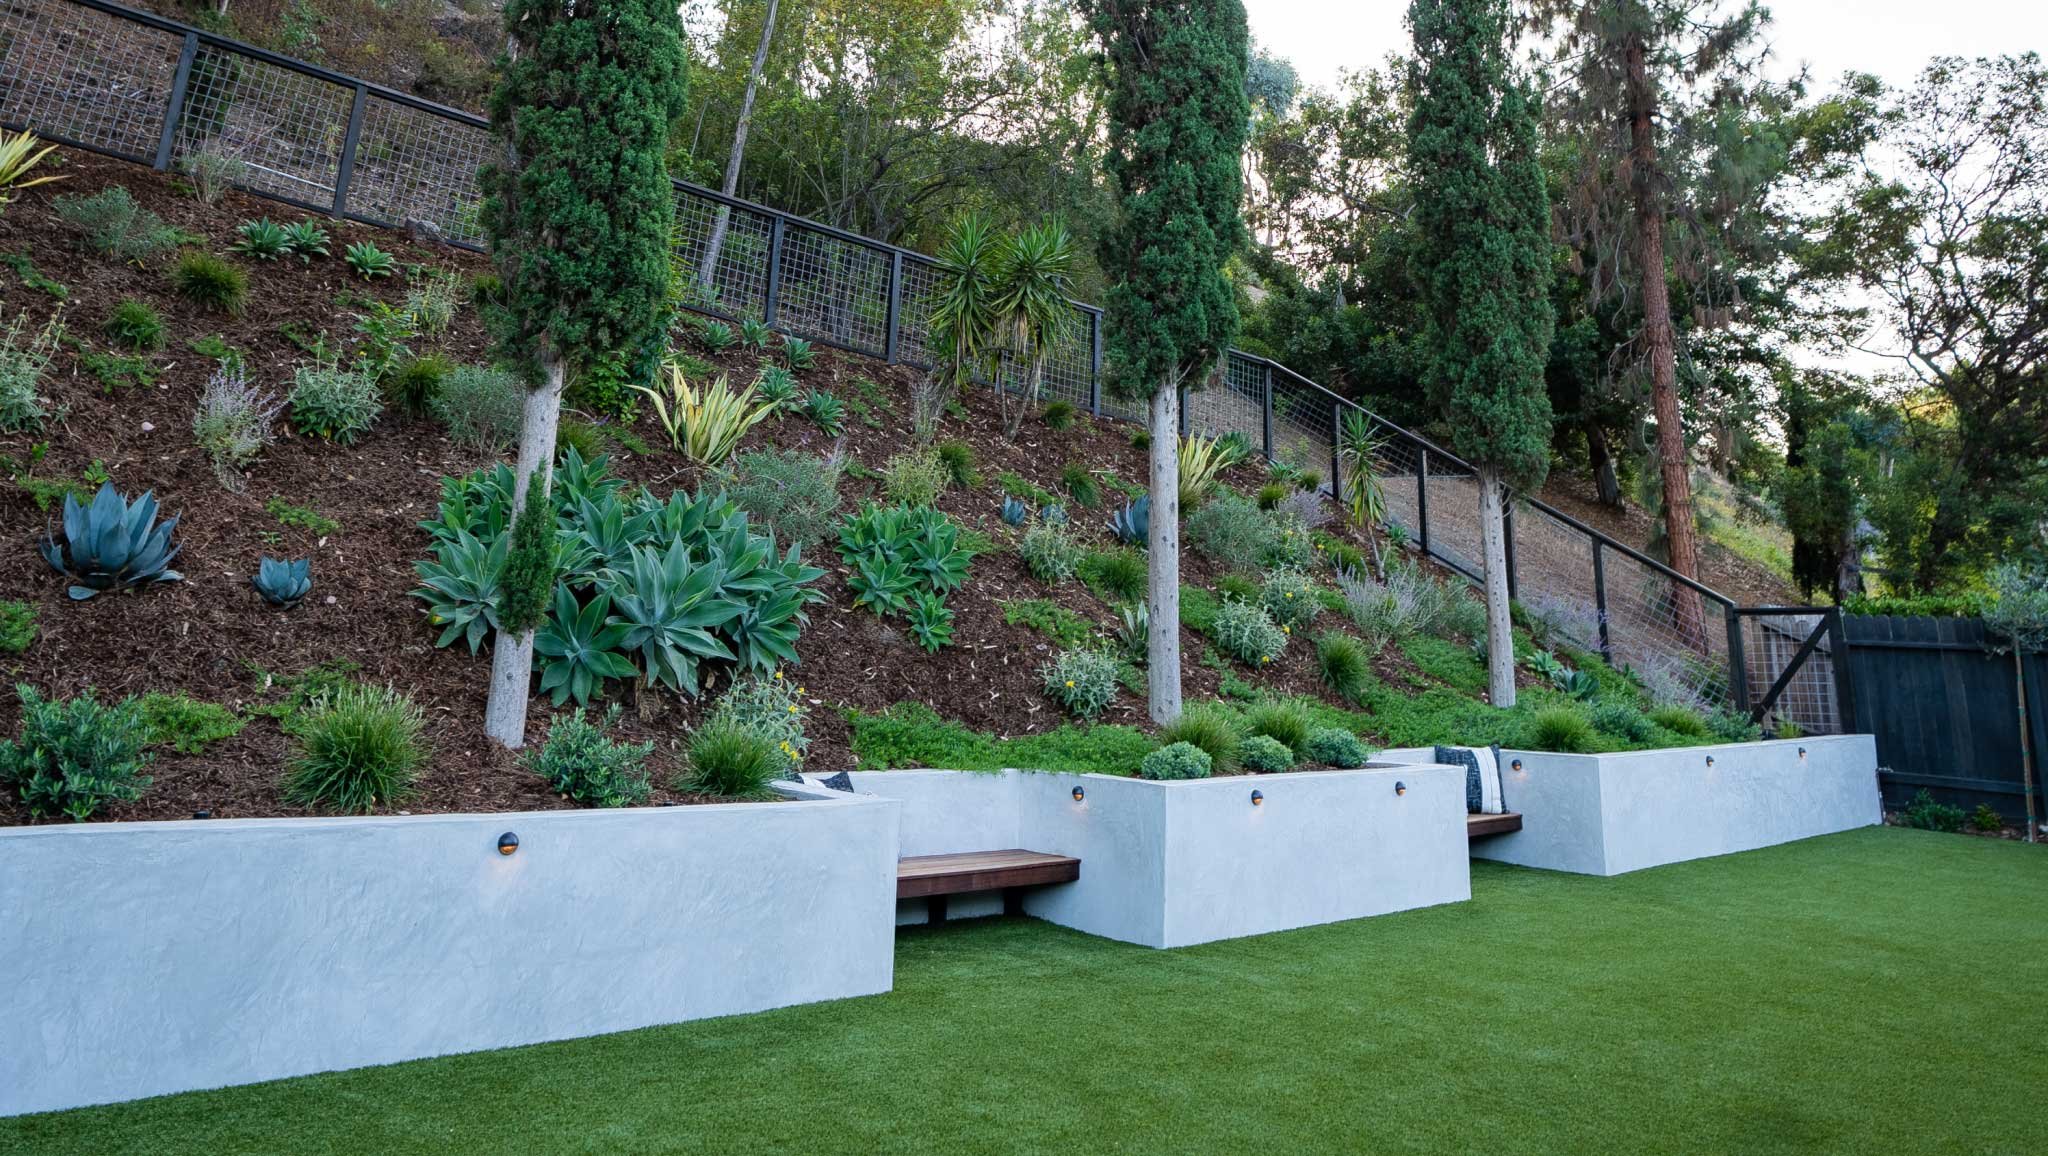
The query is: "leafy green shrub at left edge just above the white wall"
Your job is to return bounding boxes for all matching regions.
[0,683,150,822]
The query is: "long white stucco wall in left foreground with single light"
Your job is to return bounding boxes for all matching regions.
[0,789,899,1115]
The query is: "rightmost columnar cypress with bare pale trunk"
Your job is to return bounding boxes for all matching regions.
[1409,0,1554,707]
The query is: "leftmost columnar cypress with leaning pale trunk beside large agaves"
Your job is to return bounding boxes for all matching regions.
[481,0,688,748]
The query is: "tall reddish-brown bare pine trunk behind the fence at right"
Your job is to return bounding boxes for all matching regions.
[1626,35,1706,650]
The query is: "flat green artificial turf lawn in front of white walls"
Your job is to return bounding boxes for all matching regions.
[0,828,2048,1154]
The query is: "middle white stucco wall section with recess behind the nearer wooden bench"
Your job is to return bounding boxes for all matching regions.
[815,767,1470,947]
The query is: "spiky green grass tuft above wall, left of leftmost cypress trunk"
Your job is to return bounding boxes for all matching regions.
[285,683,426,814]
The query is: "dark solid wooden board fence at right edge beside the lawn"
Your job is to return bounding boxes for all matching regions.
[1843,617,2048,822]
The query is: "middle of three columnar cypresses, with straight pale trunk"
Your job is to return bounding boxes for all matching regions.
[1081,0,1251,724]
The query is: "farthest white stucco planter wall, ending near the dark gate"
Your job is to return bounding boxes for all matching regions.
[1380,734,1884,875]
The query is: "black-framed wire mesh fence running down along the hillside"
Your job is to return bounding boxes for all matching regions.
[0,0,1839,730]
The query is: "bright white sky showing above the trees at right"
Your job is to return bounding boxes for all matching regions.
[1245,0,2048,88]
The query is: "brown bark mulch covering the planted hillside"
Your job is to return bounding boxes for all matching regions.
[0,154,1474,824]
